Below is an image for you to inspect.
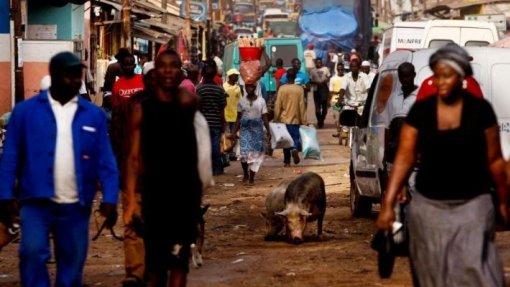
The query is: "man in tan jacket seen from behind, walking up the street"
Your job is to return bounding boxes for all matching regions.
[274,69,306,167]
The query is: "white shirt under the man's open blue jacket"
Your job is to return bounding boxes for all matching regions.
[48,91,79,203]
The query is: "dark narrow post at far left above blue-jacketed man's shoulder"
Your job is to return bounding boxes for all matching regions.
[11,0,25,103]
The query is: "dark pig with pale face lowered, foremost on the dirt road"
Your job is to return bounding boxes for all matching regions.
[277,172,326,244]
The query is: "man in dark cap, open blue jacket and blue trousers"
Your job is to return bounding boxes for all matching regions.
[0,52,119,287]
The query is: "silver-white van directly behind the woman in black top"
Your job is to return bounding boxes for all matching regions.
[341,47,510,216]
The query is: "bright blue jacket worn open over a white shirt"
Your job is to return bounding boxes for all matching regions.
[0,91,119,206]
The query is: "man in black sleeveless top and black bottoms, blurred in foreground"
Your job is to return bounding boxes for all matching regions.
[123,50,202,286]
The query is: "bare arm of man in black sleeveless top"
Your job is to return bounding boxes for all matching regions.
[123,103,142,225]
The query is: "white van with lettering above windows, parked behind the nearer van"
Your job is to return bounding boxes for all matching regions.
[379,20,499,64]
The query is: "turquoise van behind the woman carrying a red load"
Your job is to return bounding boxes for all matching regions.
[223,38,306,93]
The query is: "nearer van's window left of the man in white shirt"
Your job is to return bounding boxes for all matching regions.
[370,69,400,126]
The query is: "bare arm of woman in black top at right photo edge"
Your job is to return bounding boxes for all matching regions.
[485,125,509,225]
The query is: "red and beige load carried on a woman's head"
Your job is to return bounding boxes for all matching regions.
[239,38,264,84]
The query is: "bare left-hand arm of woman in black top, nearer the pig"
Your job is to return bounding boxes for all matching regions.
[376,124,418,230]
